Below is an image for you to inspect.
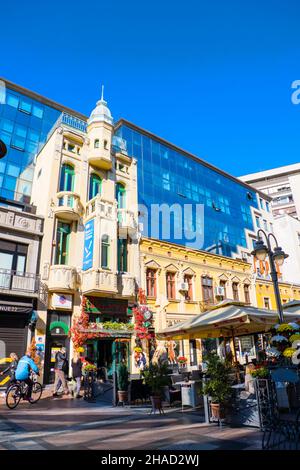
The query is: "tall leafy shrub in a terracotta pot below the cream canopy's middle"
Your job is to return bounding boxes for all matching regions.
[203,353,232,421]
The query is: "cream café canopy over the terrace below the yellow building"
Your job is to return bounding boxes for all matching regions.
[157,300,300,339]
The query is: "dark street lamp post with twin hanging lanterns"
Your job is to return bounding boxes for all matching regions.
[251,229,289,323]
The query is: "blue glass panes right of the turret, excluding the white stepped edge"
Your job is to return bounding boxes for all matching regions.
[115,124,257,256]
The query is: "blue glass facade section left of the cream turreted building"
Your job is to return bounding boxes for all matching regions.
[0,88,61,203]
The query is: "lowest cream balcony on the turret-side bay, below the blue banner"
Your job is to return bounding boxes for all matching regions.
[81,269,118,295]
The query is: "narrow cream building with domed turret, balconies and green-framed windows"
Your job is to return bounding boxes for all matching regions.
[32,96,139,382]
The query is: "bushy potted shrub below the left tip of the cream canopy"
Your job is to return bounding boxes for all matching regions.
[141,364,169,410]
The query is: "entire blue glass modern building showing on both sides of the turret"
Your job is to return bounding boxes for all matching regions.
[0,81,272,261]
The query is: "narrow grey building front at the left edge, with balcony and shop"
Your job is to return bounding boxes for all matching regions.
[0,206,44,357]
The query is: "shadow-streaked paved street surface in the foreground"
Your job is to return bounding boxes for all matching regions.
[0,391,261,450]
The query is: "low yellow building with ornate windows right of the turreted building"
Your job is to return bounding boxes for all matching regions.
[140,239,256,366]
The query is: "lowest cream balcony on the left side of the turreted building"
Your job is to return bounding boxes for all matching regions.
[48,264,77,292]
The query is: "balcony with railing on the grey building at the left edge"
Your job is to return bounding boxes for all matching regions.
[0,268,40,295]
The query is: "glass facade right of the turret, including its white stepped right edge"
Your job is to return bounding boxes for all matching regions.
[115,119,272,261]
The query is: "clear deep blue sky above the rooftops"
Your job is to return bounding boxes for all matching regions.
[0,0,300,175]
